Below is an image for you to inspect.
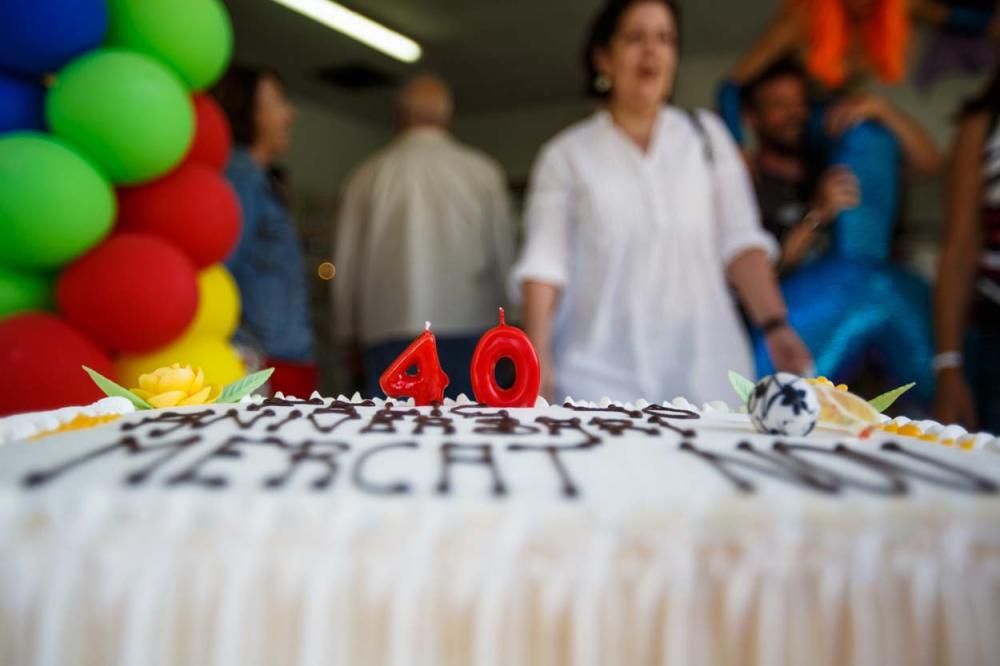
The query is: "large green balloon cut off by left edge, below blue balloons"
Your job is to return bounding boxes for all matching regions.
[0,132,115,270]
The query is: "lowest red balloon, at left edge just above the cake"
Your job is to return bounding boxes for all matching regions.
[0,312,114,416]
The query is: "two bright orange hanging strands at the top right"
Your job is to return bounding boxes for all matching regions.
[789,0,910,88]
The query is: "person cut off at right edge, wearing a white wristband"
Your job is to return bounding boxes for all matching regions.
[934,70,1000,432]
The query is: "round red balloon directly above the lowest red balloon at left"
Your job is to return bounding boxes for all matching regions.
[56,232,198,354]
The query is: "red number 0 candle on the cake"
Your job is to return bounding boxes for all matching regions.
[470,308,542,407]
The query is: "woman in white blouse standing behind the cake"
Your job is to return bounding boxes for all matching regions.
[512,0,822,403]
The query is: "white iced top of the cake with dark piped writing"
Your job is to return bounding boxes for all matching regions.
[0,395,1000,515]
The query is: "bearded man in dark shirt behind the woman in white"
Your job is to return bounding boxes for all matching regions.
[743,58,861,273]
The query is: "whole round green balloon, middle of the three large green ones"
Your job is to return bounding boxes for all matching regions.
[45,49,194,185]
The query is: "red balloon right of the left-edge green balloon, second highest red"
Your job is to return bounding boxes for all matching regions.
[117,163,242,268]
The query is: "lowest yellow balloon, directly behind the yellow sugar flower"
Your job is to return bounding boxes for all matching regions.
[117,337,246,388]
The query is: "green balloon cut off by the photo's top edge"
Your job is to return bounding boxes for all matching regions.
[108,0,233,90]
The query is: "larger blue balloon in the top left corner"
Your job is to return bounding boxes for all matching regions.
[0,0,108,76]
